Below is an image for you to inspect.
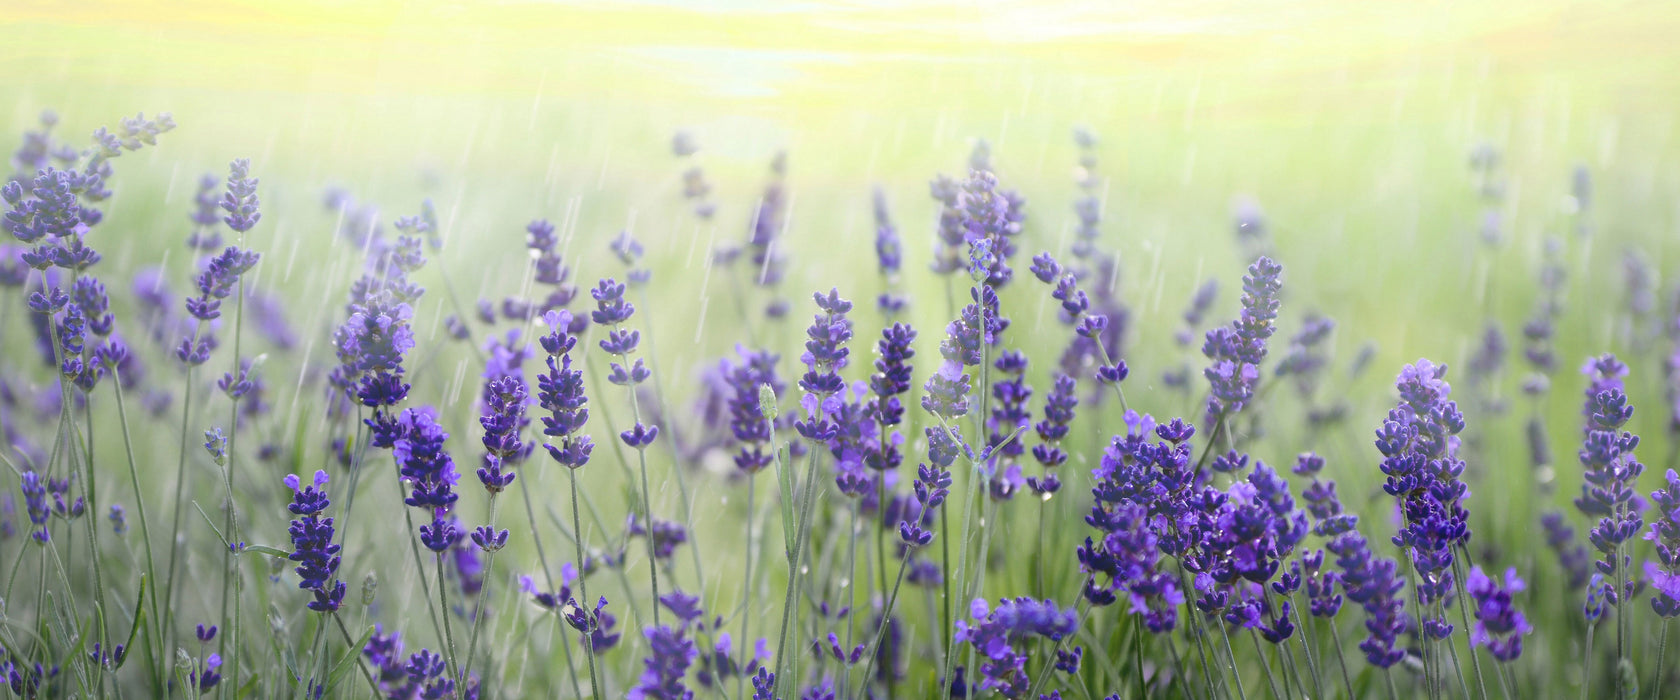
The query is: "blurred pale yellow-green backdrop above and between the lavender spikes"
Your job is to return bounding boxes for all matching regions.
[0,2,1680,691]
